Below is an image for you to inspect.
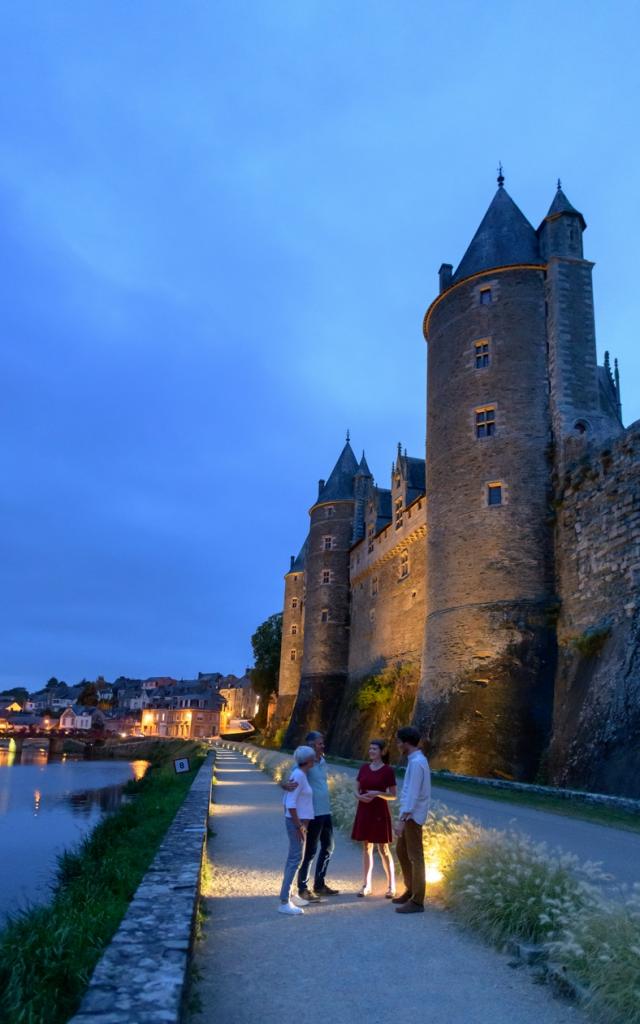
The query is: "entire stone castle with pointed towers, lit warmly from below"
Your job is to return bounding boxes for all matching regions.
[273,178,640,796]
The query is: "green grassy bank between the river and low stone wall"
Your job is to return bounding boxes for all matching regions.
[0,740,206,1024]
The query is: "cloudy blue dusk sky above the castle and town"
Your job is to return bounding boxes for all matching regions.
[0,0,640,686]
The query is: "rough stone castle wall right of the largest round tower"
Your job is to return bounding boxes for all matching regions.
[550,421,640,797]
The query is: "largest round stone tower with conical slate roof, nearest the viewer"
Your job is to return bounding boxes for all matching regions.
[417,174,555,778]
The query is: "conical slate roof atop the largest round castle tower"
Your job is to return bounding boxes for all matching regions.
[452,185,543,283]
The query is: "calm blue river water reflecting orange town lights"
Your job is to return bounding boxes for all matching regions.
[0,746,147,927]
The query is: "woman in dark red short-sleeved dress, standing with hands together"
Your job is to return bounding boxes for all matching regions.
[351,739,396,899]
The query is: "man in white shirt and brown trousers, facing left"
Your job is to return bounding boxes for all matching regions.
[393,725,431,913]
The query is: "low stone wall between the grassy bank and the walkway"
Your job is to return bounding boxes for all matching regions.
[70,752,215,1024]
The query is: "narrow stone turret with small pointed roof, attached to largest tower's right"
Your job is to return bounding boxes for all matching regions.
[538,181,622,450]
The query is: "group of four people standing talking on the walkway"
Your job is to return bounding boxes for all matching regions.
[279,726,431,915]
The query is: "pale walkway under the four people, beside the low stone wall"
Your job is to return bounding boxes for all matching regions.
[189,751,584,1024]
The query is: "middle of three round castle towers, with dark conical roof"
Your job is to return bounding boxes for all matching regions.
[286,436,366,744]
